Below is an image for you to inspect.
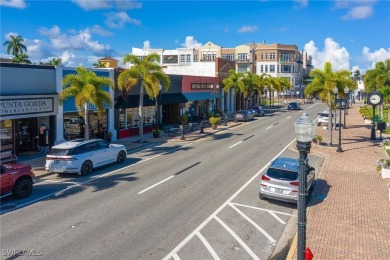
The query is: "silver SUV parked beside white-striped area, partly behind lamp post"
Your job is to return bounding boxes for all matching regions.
[259,157,315,203]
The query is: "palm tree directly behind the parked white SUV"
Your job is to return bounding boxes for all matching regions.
[58,67,114,139]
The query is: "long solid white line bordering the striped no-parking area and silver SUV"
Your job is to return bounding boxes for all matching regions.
[163,139,295,260]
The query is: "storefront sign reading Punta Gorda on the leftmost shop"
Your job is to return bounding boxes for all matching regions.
[0,97,54,116]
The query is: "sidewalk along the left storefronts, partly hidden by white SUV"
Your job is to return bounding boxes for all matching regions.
[18,121,240,176]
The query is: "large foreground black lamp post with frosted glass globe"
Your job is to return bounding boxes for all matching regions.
[294,112,314,260]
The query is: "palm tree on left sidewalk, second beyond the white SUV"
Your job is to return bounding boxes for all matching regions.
[118,53,171,142]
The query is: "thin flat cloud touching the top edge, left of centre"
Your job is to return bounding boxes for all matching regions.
[73,0,142,11]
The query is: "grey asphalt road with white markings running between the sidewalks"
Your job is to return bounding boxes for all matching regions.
[0,102,321,259]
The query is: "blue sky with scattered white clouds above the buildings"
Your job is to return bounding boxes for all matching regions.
[0,0,390,73]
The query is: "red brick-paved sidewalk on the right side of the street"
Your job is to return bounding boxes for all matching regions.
[287,104,390,260]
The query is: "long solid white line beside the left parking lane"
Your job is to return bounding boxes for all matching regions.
[0,142,193,215]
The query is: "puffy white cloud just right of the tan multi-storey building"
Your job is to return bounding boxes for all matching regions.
[304,38,350,71]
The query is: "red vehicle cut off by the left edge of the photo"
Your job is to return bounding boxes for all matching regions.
[0,163,35,199]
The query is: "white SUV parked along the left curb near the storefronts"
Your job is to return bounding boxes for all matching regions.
[45,139,127,175]
